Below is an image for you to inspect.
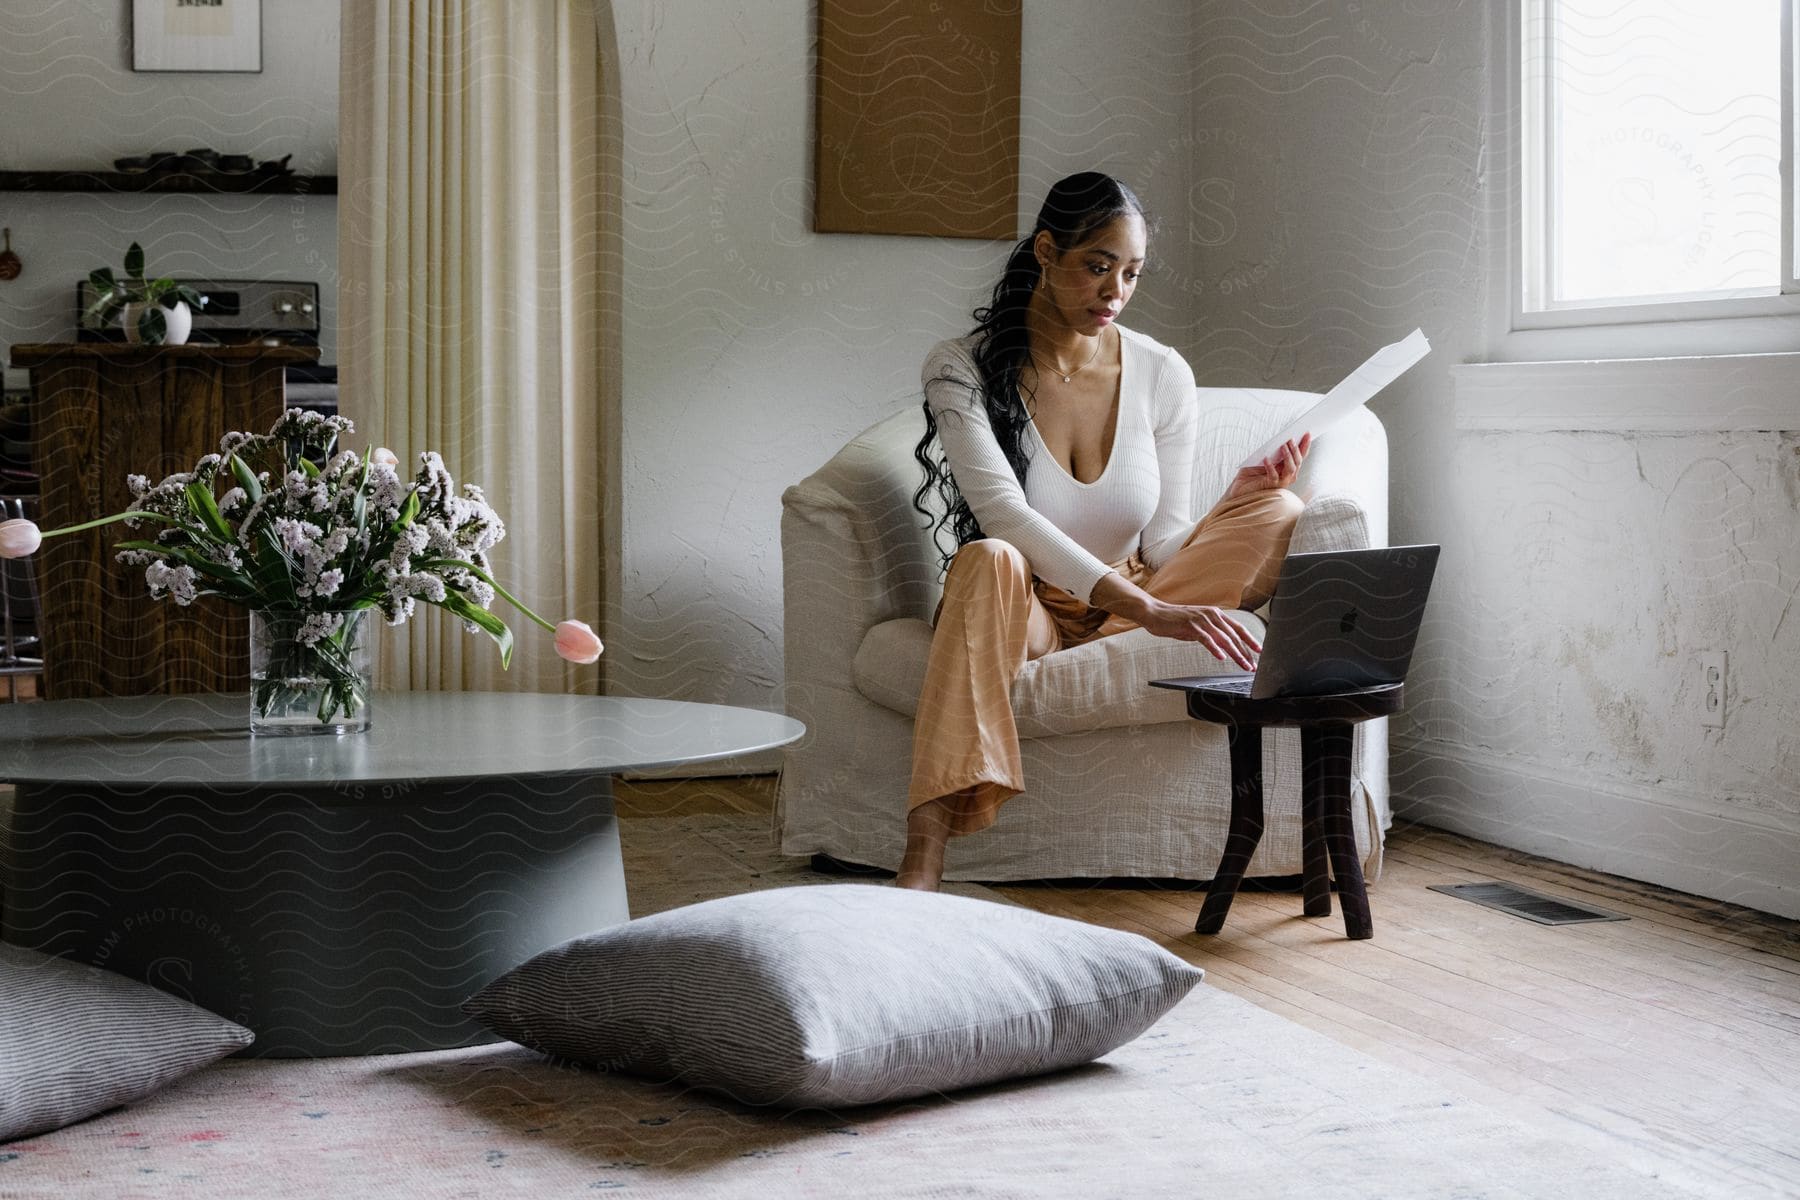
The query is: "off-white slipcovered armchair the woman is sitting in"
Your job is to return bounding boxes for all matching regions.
[776,389,1390,880]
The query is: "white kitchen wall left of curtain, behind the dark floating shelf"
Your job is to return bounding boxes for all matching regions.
[0,0,338,370]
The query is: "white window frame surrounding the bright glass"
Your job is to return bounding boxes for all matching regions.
[1489,0,1800,362]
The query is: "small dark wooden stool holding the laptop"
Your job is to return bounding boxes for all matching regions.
[1154,680,1404,939]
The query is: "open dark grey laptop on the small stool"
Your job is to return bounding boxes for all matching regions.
[1150,545,1438,700]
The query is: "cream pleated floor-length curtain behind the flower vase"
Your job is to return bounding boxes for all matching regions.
[338,0,616,691]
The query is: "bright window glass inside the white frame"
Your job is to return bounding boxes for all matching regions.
[1516,0,1800,318]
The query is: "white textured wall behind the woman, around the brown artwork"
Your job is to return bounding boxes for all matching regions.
[607,0,1192,707]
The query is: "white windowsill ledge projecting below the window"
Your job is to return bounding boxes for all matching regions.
[1451,353,1800,434]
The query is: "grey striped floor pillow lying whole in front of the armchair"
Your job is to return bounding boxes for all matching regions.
[463,883,1202,1106]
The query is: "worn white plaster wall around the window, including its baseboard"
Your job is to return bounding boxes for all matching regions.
[1190,0,1800,916]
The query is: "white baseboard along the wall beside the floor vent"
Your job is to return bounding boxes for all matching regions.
[1391,736,1800,918]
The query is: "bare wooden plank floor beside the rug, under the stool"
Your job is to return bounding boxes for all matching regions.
[617,777,1800,1195]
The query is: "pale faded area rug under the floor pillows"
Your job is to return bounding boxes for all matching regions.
[0,817,1741,1200]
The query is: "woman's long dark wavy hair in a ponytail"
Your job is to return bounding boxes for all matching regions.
[913,171,1148,567]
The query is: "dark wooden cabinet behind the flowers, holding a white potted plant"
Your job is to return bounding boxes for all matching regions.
[13,344,319,700]
